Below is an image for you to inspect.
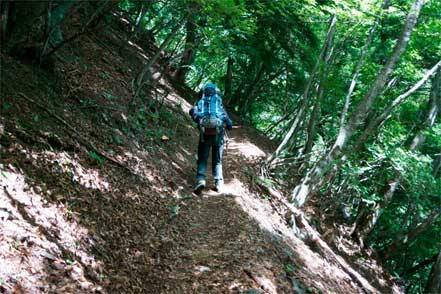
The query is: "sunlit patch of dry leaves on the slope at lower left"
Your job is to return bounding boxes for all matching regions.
[0,166,103,292]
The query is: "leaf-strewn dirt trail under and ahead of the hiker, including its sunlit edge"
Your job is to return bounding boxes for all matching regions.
[138,127,372,293]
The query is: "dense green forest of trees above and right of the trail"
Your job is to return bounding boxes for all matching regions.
[0,0,441,293]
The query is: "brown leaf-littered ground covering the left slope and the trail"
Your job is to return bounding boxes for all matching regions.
[0,12,400,293]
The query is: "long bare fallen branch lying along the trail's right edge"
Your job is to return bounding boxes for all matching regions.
[258,183,378,293]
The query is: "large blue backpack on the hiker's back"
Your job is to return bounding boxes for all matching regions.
[197,84,225,135]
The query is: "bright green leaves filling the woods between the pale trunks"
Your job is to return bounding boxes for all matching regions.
[20,0,434,292]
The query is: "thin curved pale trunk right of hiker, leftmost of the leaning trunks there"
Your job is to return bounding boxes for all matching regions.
[265,15,337,164]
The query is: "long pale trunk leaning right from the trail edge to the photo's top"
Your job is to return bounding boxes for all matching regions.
[291,0,424,206]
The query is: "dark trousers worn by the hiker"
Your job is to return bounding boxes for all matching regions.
[196,136,224,184]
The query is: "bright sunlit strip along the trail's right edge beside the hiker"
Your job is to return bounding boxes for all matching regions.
[220,137,372,293]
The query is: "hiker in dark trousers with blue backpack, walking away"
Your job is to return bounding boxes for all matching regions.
[190,83,233,194]
